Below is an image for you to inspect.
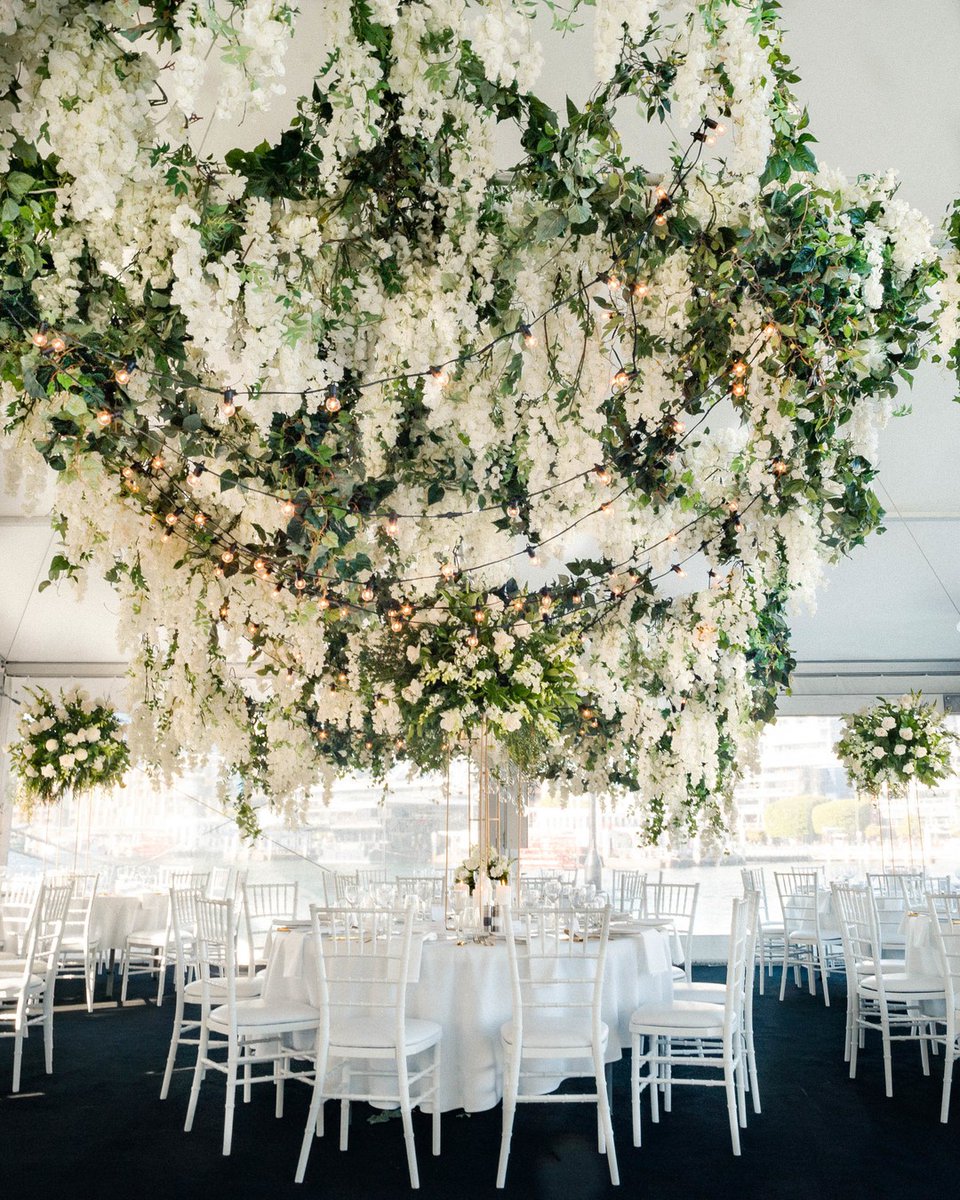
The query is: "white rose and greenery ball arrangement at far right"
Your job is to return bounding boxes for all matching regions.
[834,692,960,797]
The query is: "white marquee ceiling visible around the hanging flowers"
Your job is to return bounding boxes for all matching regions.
[0,0,960,690]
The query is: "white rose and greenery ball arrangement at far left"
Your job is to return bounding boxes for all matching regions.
[8,688,130,808]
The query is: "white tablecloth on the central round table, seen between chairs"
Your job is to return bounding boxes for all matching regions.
[263,929,673,1112]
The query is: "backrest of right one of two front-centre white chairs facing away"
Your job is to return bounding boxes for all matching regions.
[503,905,611,1044]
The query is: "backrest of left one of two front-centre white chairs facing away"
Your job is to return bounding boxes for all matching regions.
[310,902,421,1031]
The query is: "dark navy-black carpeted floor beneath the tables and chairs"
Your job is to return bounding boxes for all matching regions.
[0,971,960,1200]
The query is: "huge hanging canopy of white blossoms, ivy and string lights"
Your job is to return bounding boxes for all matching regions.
[0,0,960,839]
